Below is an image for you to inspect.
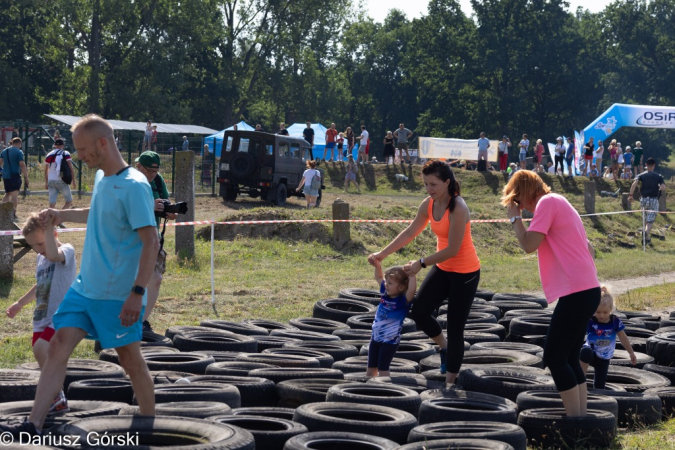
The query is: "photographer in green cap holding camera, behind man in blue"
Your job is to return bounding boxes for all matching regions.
[136,151,176,331]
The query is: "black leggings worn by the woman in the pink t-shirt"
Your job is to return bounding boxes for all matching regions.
[544,287,600,392]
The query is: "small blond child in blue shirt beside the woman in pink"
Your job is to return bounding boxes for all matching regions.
[579,286,637,389]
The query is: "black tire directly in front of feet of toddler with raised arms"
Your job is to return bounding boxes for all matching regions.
[326,382,422,417]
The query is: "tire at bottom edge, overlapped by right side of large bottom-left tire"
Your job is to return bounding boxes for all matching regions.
[209,414,307,450]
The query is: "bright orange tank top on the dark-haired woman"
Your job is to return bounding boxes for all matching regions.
[428,199,480,273]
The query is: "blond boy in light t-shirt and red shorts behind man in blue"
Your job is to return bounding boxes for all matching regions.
[6,214,77,413]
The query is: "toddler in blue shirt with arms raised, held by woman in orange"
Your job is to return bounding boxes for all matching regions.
[366,260,417,377]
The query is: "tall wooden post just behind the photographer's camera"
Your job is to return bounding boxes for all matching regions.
[174,151,195,259]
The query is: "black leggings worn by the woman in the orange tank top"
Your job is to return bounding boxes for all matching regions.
[410,266,480,373]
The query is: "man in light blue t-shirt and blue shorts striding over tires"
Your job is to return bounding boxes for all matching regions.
[0,114,159,436]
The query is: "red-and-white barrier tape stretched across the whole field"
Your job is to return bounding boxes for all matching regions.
[0,209,675,236]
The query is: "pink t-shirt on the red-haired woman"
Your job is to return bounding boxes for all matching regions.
[528,194,600,303]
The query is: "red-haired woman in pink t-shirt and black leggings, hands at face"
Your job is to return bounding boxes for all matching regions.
[501,170,600,417]
